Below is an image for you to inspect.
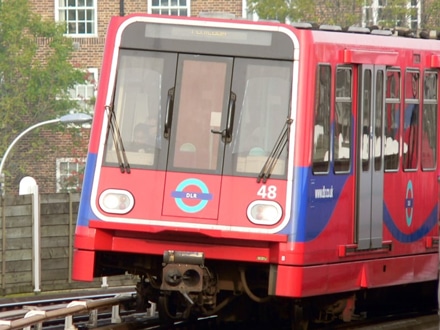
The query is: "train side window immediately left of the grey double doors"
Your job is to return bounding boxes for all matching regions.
[333,67,353,173]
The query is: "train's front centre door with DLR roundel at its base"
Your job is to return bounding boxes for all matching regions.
[162,54,235,221]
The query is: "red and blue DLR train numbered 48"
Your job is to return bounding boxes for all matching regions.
[72,14,440,329]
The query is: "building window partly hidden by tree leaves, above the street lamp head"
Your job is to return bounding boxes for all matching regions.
[69,68,98,114]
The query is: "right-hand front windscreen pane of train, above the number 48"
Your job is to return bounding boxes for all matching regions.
[233,61,291,175]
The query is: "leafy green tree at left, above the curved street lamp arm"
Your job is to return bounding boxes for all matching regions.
[0,0,84,186]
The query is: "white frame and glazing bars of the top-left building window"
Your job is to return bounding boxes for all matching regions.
[54,0,98,38]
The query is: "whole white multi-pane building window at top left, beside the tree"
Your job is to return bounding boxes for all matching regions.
[55,0,97,37]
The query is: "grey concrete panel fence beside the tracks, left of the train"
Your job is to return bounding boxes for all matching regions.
[0,193,137,296]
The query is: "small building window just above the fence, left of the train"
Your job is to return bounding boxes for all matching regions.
[57,158,86,193]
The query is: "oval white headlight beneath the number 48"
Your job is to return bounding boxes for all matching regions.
[247,201,283,226]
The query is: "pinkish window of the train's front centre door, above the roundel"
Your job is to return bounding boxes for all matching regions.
[168,55,232,173]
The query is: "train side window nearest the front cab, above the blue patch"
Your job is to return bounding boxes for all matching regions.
[312,65,331,174]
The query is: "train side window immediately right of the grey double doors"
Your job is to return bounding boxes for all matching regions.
[384,68,400,171]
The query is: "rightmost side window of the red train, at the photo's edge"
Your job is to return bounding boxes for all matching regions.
[421,71,438,170]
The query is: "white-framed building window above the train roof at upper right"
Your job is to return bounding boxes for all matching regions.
[362,0,422,30]
